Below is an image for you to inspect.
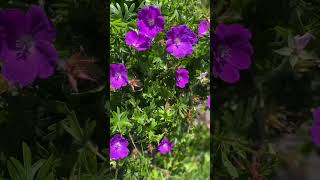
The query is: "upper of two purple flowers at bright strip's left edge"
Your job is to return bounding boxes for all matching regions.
[110,64,128,89]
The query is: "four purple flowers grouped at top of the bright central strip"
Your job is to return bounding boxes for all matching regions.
[125,6,210,58]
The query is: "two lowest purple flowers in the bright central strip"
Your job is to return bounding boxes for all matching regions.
[110,134,174,160]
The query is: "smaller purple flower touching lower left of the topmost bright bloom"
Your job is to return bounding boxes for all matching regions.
[125,31,152,51]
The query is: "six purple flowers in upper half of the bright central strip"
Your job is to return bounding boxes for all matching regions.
[110,6,210,89]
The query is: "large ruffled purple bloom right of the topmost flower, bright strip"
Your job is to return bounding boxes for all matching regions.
[167,25,198,58]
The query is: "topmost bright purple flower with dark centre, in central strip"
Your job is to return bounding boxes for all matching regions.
[137,6,164,39]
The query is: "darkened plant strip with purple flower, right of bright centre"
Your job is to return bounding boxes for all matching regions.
[211,0,320,180]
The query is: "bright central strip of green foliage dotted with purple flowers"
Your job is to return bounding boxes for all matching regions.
[109,0,210,179]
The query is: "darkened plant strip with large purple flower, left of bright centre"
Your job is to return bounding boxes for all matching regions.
[0,0,109,180]
